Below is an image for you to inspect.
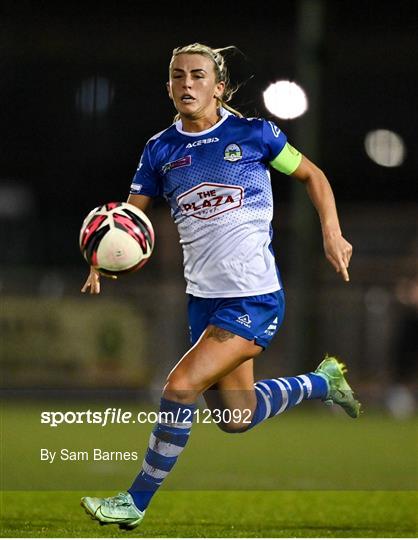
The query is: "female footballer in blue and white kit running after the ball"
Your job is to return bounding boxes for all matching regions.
[81,43,360,529]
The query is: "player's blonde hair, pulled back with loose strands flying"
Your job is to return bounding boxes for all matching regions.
[169,43,242,122]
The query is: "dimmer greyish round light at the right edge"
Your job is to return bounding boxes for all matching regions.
[364,129,405,167]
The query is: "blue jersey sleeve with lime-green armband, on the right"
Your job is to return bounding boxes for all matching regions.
[263,120,302,174]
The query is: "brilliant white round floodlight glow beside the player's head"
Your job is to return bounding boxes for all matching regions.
[263,81,308,120]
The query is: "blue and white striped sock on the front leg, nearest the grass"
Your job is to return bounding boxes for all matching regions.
[128,398,196,511]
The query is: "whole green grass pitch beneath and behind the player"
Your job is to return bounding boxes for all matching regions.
[0,402,418,538]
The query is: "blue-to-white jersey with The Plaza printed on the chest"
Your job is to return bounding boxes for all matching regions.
[130,109,300,298]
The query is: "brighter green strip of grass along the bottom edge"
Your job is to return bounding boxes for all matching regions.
[1,491,417,538]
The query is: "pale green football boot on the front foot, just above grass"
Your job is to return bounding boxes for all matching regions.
[80,491,145,530]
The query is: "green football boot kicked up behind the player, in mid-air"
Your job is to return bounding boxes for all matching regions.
[314,355,361,418]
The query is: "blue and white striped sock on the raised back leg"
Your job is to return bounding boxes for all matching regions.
[248,373,328,429]
